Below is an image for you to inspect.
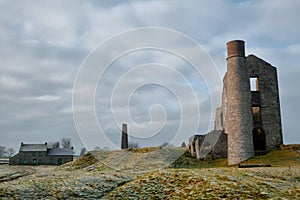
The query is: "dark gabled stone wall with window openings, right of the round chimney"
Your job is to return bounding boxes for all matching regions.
[247,55,283,150]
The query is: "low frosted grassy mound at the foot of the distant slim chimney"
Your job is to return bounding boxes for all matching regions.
[62,147,186,173]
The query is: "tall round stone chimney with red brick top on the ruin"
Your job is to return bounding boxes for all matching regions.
[225,41,254,165]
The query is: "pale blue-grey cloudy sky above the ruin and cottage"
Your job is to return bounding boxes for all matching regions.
[0,0,300,152]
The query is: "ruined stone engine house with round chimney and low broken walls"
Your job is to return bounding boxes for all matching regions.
[189,40,283,165]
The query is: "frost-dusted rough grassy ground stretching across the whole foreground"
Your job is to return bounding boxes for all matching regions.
[0,146,300,199]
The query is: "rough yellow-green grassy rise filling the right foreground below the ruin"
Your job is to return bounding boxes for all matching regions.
[107,168,300,199]
